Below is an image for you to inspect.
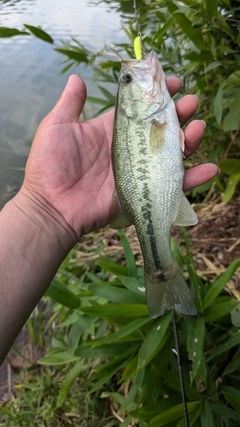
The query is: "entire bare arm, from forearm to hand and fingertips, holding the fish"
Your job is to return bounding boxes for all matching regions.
[0,76,218,364]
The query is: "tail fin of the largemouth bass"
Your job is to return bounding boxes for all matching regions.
[145,265,196,317]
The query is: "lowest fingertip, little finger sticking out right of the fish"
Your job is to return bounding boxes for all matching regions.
[183,163,219,191]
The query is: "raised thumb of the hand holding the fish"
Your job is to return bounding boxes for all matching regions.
[50,74,86,123]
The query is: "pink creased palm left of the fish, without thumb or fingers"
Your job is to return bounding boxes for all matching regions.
[25,105,114,236]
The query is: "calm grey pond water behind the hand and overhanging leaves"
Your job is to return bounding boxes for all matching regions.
[0,0,129,208]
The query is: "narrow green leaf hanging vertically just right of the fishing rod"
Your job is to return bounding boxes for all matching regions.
[187,317,205,382]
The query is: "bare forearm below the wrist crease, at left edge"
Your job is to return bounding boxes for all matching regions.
[0,192,77,364]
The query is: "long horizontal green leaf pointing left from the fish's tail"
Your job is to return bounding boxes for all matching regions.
[81,304,148,318]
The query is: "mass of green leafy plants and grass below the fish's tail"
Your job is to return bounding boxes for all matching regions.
[0,230,240,427]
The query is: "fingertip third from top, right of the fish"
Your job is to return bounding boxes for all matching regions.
[184,120,206,157]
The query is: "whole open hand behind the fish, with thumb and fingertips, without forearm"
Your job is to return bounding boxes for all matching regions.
[21,75,218,237]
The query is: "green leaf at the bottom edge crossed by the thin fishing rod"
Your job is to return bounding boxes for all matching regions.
[147,402,201,427]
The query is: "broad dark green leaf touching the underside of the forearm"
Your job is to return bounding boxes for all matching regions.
[45,279,81,308]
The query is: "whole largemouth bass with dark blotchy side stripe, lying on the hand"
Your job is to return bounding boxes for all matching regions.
[110,52,198,317]
